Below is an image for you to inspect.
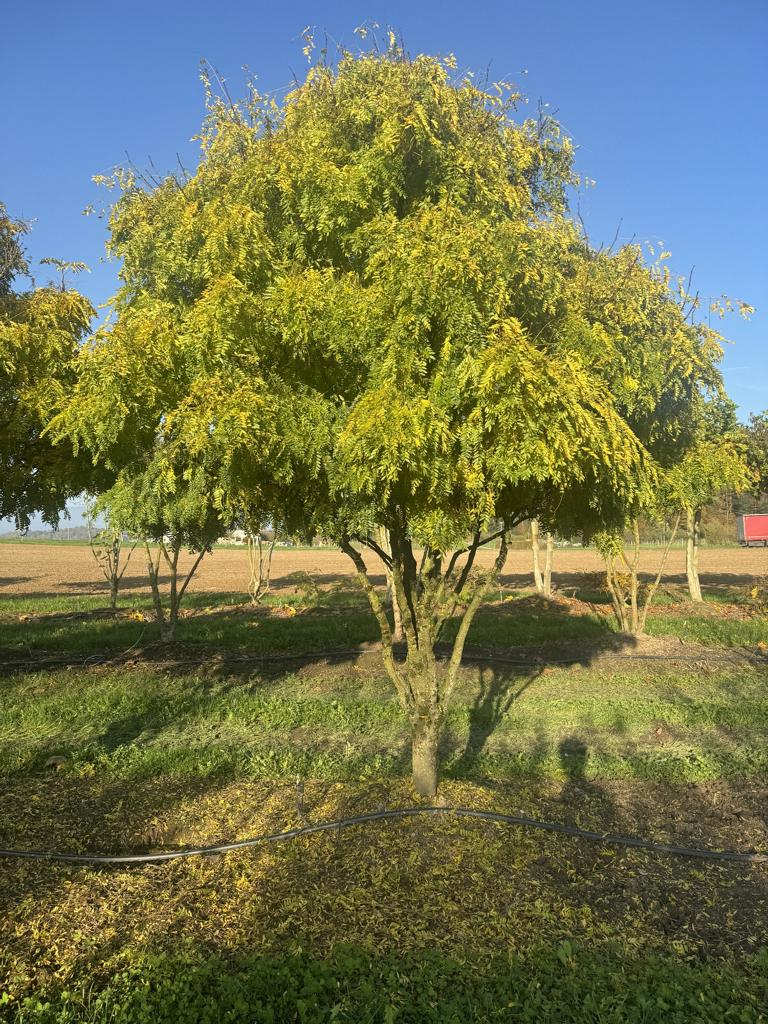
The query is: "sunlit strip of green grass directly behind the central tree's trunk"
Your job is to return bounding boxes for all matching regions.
[0,669,768,781]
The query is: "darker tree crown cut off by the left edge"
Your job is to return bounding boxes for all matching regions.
[0,203,103,529]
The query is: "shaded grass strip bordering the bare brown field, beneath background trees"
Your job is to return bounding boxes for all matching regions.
[0,584,768,656]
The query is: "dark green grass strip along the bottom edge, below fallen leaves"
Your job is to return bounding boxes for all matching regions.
[7,940,768,1024]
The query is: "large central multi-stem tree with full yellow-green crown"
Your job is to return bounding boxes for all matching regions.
[61,41,729,796]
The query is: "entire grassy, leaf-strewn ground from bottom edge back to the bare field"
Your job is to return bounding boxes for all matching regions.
[0,589,768,1024]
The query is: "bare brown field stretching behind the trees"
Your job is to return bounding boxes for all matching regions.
[0,541,768,599]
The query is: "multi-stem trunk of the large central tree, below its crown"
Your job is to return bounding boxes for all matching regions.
[341,527,507,798]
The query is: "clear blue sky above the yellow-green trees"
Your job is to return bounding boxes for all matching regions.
[0,0,768,528]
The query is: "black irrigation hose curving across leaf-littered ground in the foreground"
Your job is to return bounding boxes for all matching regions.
[0,807,768,864]
